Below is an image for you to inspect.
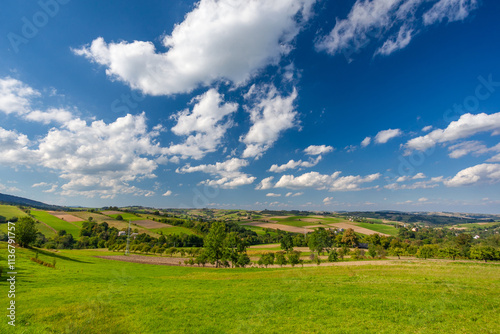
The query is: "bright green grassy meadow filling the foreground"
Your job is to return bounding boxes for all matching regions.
[0,243,500,334]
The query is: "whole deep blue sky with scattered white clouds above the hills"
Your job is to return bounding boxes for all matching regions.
[0,0,500,213]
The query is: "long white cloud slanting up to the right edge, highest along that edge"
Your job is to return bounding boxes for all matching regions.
[405,112,500,151]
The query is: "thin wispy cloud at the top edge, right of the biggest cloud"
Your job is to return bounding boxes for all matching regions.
[316,0,478,58]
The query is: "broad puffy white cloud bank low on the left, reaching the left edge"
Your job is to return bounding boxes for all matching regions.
[0,113,167,198]
